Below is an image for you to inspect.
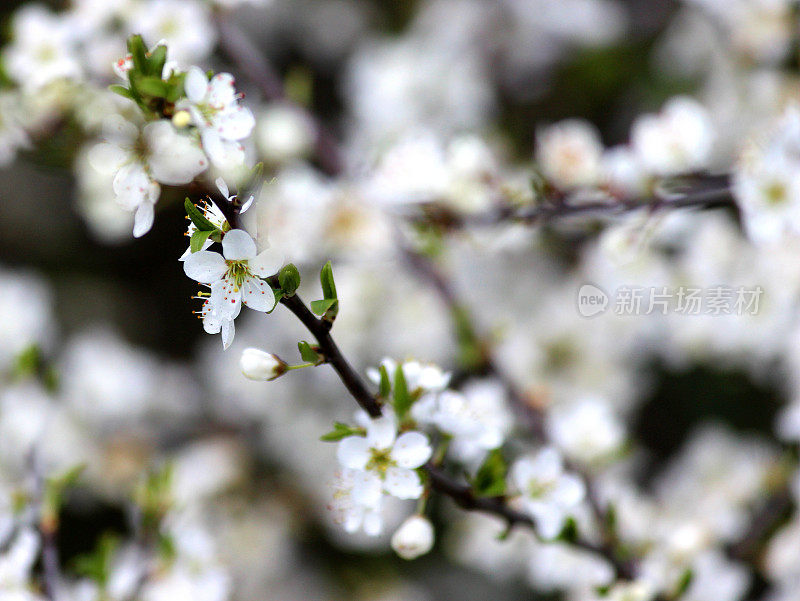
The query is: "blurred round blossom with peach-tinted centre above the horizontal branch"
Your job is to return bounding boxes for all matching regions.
[536,119,603,188]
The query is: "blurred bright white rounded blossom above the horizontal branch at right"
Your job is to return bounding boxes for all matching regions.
[631,96,714,175]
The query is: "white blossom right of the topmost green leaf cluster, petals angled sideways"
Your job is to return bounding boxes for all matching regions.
[178,67,255,169]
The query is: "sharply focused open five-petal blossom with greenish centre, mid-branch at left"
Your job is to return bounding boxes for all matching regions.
[183,229,283,337]
